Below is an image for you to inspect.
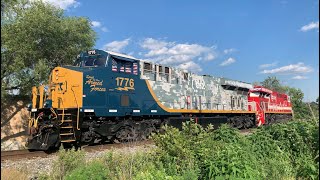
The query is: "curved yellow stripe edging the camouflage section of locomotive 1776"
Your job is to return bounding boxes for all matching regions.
[145,79,256,113]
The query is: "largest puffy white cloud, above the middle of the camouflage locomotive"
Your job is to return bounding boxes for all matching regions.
[140,38,217,71]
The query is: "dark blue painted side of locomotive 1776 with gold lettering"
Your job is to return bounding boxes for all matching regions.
[65,50,180,117]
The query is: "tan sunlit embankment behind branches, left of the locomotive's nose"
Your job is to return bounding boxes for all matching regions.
[1,100,29,151]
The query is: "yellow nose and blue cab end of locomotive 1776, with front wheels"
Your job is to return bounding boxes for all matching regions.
[27,50,141,150]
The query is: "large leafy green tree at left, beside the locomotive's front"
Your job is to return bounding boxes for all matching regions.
[1,1,96,99]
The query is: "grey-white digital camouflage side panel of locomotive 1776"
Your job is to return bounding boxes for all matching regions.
[140,62,251,112]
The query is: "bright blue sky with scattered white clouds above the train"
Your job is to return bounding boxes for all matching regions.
[46,0,319,101]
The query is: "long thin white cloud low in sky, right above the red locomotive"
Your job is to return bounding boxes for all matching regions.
[261,62,313,74]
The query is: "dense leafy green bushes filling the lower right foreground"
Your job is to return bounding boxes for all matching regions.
[153,121,319,179]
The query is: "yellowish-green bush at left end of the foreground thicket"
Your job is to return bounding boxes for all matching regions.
[152,121,202,179]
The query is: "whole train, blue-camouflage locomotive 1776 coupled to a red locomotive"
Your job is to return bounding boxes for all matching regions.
[26,49,293,150]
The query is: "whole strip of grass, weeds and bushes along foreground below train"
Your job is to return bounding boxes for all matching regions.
[38,119,319,180]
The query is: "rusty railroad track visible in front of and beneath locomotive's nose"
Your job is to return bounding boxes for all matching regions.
[1,140,153,161]
